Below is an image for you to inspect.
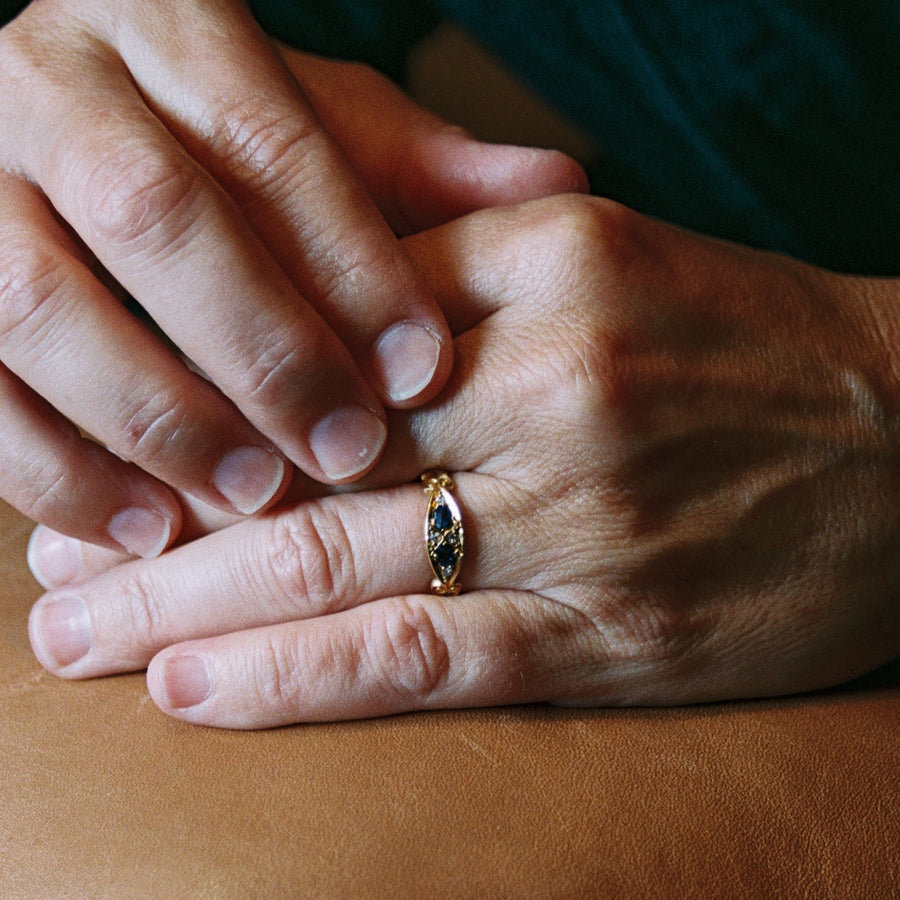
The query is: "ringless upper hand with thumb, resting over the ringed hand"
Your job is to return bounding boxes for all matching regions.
[0,0,583,556]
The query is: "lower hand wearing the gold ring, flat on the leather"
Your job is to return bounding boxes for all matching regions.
[30,197,900,728]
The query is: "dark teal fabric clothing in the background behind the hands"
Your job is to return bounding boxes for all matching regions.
[7,0,900,275]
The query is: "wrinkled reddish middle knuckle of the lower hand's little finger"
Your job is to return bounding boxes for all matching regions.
[362,597,450,707]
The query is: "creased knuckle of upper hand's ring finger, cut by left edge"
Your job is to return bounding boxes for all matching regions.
[0,236,67,350]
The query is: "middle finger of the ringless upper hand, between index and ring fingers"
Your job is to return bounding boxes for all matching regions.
[0,12,385,481]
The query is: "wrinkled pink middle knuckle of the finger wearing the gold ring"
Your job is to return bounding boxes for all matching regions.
[267,503,358,615]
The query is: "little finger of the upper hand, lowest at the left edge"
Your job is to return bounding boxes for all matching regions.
[0,366,181,557]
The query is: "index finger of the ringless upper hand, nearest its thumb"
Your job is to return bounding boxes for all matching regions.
[116,0,451,406]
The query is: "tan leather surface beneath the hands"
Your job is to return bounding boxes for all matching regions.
[0,500,900,900]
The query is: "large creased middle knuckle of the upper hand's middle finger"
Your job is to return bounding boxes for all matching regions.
[81,142,201,253]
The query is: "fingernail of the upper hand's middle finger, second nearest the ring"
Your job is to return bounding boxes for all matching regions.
[309,406,387,481]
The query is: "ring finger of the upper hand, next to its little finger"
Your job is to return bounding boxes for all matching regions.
[0,175,289,516]
